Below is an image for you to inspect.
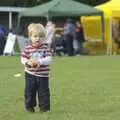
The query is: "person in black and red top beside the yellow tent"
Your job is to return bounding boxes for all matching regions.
[75,21,85,54]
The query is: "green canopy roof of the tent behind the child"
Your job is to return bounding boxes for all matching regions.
[19,0,102,17]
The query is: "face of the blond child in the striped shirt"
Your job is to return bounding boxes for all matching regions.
[30,32,45,46]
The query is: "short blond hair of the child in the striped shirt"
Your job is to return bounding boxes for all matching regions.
[27,23,45,37]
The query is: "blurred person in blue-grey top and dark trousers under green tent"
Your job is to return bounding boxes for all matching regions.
[64,19,75,56]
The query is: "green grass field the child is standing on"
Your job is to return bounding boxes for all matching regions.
[0,56,120,120]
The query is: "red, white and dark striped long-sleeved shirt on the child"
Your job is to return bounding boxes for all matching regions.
[21,44,51,77]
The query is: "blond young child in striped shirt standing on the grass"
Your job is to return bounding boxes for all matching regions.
[21,23,51,112]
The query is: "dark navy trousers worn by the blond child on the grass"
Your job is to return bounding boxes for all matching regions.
[25,73,50,111]
